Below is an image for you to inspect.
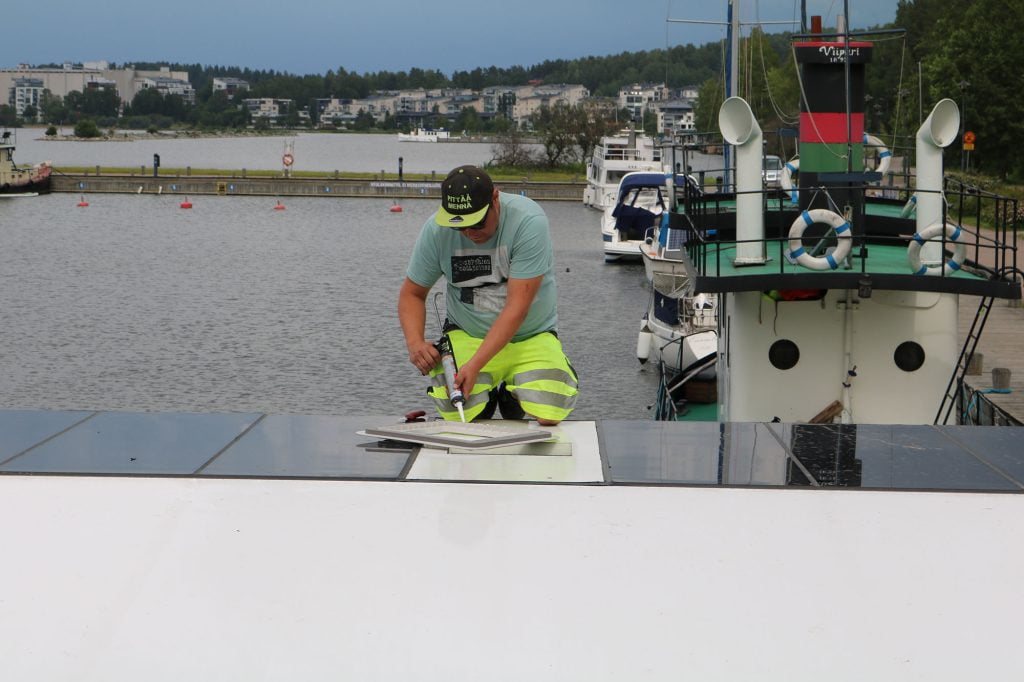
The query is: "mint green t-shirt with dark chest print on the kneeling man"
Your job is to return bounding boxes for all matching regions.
[406,193,558,341]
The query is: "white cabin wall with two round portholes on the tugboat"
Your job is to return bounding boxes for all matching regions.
[719,291,959,424]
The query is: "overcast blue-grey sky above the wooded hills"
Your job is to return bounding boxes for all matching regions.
[0,0,896,76]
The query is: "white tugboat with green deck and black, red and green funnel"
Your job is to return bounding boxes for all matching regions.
[656,18,1021,424]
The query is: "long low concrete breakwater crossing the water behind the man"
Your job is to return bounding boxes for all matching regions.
[51,174,586,202]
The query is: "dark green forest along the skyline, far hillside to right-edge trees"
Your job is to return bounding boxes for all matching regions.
[0,0,1024,178]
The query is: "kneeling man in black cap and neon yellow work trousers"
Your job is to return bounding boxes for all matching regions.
[398,166,579,426]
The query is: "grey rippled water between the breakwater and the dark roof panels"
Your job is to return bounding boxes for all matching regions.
[0,188,657,419]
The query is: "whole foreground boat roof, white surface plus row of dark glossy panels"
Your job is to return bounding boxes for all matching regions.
[0,411,1024,682]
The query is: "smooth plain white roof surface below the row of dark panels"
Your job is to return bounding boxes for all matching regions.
[0,475,1024,682]
